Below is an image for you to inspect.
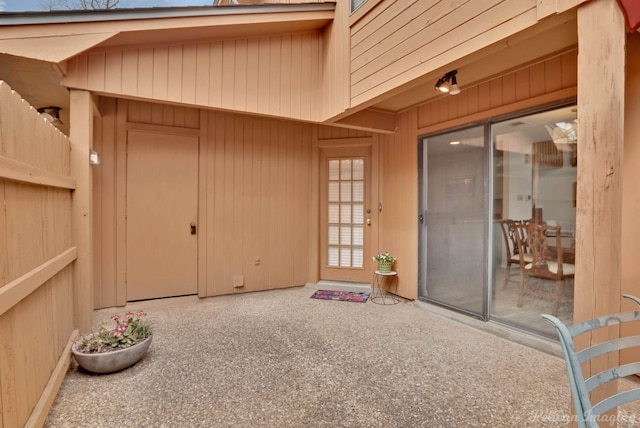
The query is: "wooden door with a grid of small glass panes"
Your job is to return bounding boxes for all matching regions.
[320,146,373,282]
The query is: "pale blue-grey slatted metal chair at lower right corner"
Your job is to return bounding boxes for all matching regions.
[542,294,640,428]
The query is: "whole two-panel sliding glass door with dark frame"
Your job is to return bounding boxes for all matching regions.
[419,106,578,337]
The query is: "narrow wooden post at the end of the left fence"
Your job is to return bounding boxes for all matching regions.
[69,89,93,333]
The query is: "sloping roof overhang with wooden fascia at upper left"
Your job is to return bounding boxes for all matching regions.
[0,3,335,63]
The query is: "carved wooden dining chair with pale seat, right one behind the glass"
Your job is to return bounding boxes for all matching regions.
[515,222,576,316]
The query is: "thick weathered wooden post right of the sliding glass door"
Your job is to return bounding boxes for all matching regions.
[574,0,626,420]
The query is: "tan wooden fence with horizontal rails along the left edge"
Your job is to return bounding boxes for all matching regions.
[0,81,77,428]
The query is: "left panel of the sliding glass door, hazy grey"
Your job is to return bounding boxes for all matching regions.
[420,127,487,317]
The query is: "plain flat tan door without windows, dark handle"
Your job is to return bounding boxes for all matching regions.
[126,132,198,301]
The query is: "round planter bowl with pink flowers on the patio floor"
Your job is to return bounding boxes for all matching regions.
[71,311,153,373]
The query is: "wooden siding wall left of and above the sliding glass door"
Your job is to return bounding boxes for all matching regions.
[380,51,577,298]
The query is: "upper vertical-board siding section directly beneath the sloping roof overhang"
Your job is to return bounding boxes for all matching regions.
[62,33,322,120]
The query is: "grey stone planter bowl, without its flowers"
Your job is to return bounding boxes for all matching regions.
[71,336,153,373]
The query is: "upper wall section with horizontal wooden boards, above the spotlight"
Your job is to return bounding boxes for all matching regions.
[350,0,537,105]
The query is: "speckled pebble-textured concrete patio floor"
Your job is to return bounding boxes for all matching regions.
[45,288,640,427]
